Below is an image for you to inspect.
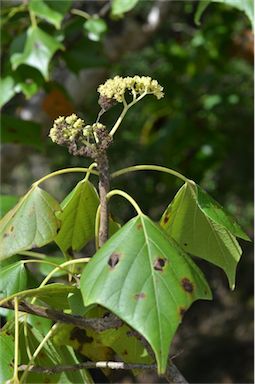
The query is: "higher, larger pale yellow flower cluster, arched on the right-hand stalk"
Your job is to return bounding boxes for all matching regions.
[98,76,164,103]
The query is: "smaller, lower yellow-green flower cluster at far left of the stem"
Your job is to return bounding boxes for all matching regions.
[49,113,85,144]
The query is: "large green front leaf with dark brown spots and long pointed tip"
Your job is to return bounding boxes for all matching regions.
[80,215,211,374]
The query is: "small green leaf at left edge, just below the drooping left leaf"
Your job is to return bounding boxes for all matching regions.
[0,261,27,298]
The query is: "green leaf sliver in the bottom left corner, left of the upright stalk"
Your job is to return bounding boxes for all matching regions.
[0,332,14,383]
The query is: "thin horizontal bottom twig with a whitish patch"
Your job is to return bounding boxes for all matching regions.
[19,361,157,375]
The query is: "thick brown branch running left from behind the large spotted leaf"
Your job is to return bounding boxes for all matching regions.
[1,301,123,332]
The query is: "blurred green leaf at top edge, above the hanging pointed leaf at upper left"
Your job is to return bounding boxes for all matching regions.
[28,0,63,29]
